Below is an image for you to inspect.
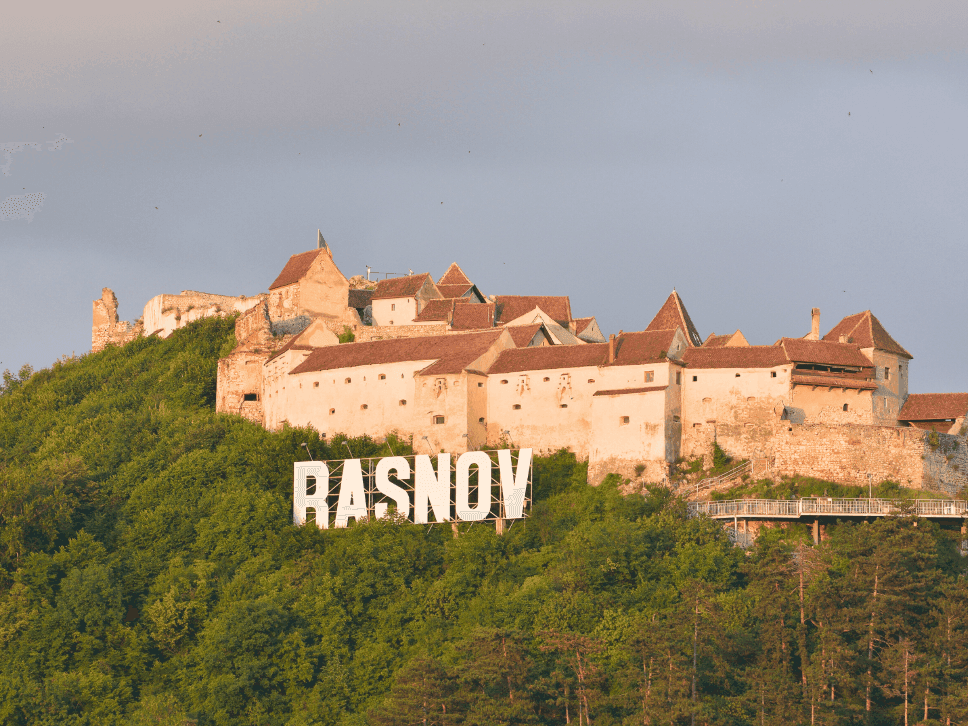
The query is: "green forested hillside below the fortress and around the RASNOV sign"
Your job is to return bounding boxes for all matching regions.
[0,319,968,726]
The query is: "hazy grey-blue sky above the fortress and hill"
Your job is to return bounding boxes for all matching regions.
[0,0,968,392]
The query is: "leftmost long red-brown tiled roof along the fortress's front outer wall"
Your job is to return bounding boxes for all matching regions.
[290,330,502,375]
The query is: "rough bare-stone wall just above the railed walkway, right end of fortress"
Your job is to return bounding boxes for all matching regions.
[773,422,968,494]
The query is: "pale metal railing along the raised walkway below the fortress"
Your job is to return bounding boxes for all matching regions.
[686,497,968,519]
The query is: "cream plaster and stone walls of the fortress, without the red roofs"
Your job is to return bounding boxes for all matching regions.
[92,235,968,493]
